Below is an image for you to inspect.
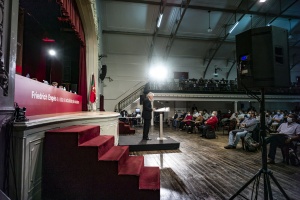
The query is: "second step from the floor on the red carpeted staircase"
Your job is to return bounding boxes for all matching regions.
[118,156,144,176]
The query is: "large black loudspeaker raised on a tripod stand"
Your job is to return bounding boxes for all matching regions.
[236,26,290,89]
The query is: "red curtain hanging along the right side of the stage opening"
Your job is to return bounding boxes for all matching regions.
[57,0,87,111]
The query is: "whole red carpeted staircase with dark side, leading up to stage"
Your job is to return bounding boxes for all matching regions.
[42,125,160,200]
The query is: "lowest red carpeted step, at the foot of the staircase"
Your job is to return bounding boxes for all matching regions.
[139,167,160,190]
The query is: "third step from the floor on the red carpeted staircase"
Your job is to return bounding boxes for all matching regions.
[99,146,129,166]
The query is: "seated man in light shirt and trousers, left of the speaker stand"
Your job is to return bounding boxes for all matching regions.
[224,111,258,149]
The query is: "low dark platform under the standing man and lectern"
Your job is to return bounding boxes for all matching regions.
[119,134,180,151]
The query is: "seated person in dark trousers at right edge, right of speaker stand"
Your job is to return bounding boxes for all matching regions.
[266,114,300,164]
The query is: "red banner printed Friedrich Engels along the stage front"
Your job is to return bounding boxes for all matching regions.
[15,74,82,116]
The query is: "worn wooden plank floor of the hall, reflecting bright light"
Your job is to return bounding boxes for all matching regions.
[131,126,300,200]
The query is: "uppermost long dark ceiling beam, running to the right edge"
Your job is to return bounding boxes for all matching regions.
[105,0,300,19]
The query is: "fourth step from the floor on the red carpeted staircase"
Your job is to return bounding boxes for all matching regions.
[79,135,115,159]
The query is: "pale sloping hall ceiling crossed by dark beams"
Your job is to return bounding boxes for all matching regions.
[97,0,300,77]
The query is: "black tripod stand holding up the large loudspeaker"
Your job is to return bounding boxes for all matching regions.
[230,89,290,200]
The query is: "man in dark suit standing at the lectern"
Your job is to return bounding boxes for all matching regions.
[142,92,155,140]
